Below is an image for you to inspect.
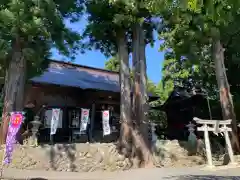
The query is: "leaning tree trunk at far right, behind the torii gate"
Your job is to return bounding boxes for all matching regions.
[213,40,240,152]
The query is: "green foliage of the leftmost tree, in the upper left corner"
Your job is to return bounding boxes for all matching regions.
[0,0,83,76]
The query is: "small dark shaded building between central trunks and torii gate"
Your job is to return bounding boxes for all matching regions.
[158,87,212,140]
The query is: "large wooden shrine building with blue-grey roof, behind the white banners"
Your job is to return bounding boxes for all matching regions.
[22,61,157,142]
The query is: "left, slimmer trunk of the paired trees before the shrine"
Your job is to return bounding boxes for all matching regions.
[118,32,132,156]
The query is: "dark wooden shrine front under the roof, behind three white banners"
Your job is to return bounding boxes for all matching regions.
[24,84,120,142]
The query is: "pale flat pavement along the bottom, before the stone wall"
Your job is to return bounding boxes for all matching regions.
[3,166,240,180]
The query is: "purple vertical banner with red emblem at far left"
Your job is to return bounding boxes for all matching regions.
[3,112,24,164]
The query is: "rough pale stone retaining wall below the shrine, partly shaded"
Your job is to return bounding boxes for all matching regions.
[0,140,218,172]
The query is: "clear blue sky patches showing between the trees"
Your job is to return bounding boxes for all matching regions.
[52,18,164,83]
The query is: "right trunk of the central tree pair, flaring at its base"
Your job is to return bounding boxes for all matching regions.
[132,24,153,166]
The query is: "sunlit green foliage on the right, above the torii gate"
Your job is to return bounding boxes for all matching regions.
[150,0,240,102]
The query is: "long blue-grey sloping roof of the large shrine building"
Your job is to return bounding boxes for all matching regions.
[31,61,120,92]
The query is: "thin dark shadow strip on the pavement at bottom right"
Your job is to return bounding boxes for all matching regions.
[164,175,240,180]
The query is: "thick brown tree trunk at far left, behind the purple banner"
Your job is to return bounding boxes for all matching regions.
[1,42,26,143]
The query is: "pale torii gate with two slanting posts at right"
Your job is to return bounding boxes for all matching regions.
[193,117,236,168]
